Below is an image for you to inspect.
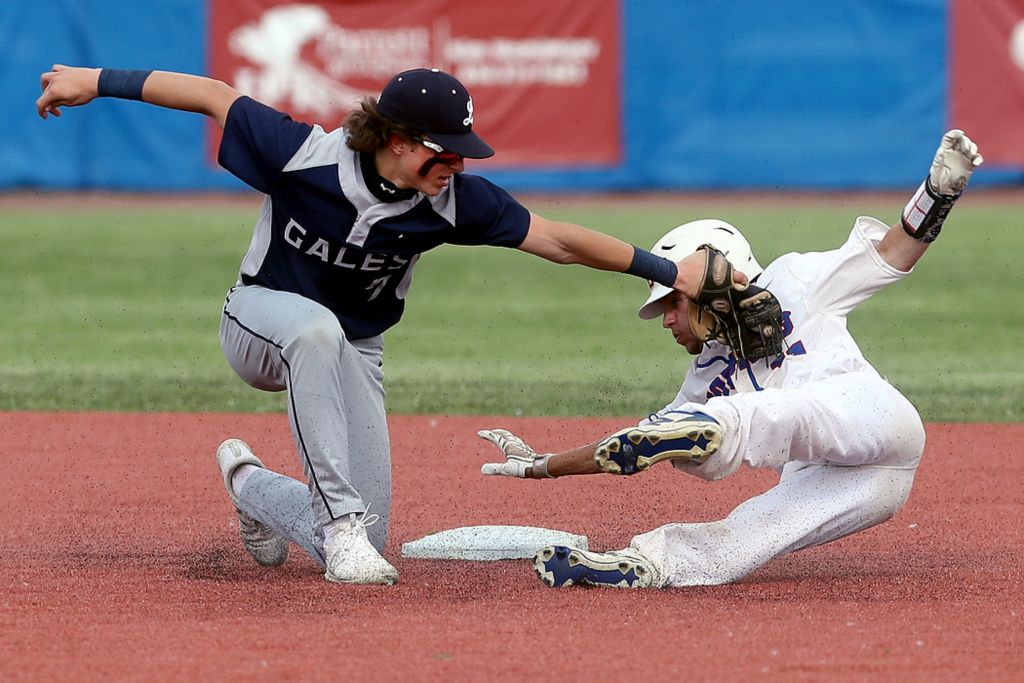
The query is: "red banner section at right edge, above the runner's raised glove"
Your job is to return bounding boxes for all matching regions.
[949,0,1024,166]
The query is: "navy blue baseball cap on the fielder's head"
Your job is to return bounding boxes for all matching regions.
[377,69,495,159]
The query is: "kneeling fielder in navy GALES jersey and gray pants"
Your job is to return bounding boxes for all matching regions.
[36,65,720,584]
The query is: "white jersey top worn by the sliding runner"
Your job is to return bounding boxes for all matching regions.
[651,216,909,417]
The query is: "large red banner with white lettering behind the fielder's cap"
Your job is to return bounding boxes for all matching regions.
[209,0,621,167]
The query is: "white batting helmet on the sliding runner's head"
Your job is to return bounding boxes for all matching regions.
[639,218,764,321]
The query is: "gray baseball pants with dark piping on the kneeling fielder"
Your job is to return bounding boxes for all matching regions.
[220,285,391,564]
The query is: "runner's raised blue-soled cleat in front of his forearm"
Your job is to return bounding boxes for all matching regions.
[594,412,722,474]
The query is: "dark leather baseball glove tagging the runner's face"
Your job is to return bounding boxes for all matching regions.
[690,245,782,359]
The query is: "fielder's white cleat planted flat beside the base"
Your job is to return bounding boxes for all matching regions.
[324,512,398,586]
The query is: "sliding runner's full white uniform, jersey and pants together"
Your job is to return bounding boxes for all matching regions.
[630,217,925,586]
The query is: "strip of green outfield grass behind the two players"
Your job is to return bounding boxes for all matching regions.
[0,201,1024,422]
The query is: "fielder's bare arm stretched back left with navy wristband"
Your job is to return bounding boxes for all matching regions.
[36,65,242,126]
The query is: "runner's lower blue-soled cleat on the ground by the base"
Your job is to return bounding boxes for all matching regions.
[534,546,660,588]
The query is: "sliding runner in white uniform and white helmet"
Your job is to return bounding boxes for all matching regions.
[480,130,982,588]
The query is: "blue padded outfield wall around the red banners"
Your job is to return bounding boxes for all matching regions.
[0,0,1020,190]
